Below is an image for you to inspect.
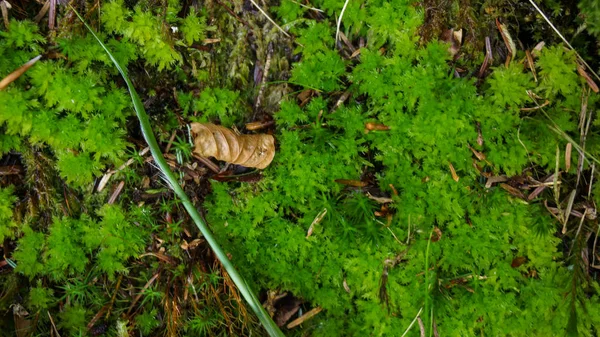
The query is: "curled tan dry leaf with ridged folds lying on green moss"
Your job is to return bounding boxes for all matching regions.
[190,123,275,169]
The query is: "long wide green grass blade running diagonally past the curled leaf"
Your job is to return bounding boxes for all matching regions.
[71,7,283,336]
